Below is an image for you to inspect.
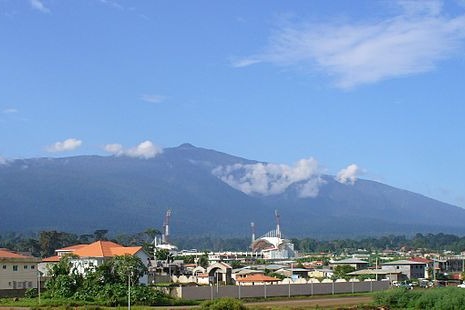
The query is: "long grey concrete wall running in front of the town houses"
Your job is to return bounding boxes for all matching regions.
[176,281,389,300]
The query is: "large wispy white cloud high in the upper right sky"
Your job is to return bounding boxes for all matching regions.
[233,1,465,89]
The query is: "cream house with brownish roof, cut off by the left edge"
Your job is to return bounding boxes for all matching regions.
[0,248,40,290]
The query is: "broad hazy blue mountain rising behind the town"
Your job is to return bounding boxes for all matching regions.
[0,144,465,238]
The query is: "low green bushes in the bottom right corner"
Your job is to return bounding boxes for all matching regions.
[374,287,465,310]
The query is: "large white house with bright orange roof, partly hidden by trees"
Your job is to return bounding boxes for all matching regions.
[40,241,150,284]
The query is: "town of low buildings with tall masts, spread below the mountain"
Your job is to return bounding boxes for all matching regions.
[0,210,465,300]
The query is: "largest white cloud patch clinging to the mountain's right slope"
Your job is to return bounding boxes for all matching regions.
[212,158,324,197]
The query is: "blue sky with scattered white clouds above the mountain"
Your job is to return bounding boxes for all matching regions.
[0,0,465,207]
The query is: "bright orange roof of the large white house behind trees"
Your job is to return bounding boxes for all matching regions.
[52,241,142,257]
